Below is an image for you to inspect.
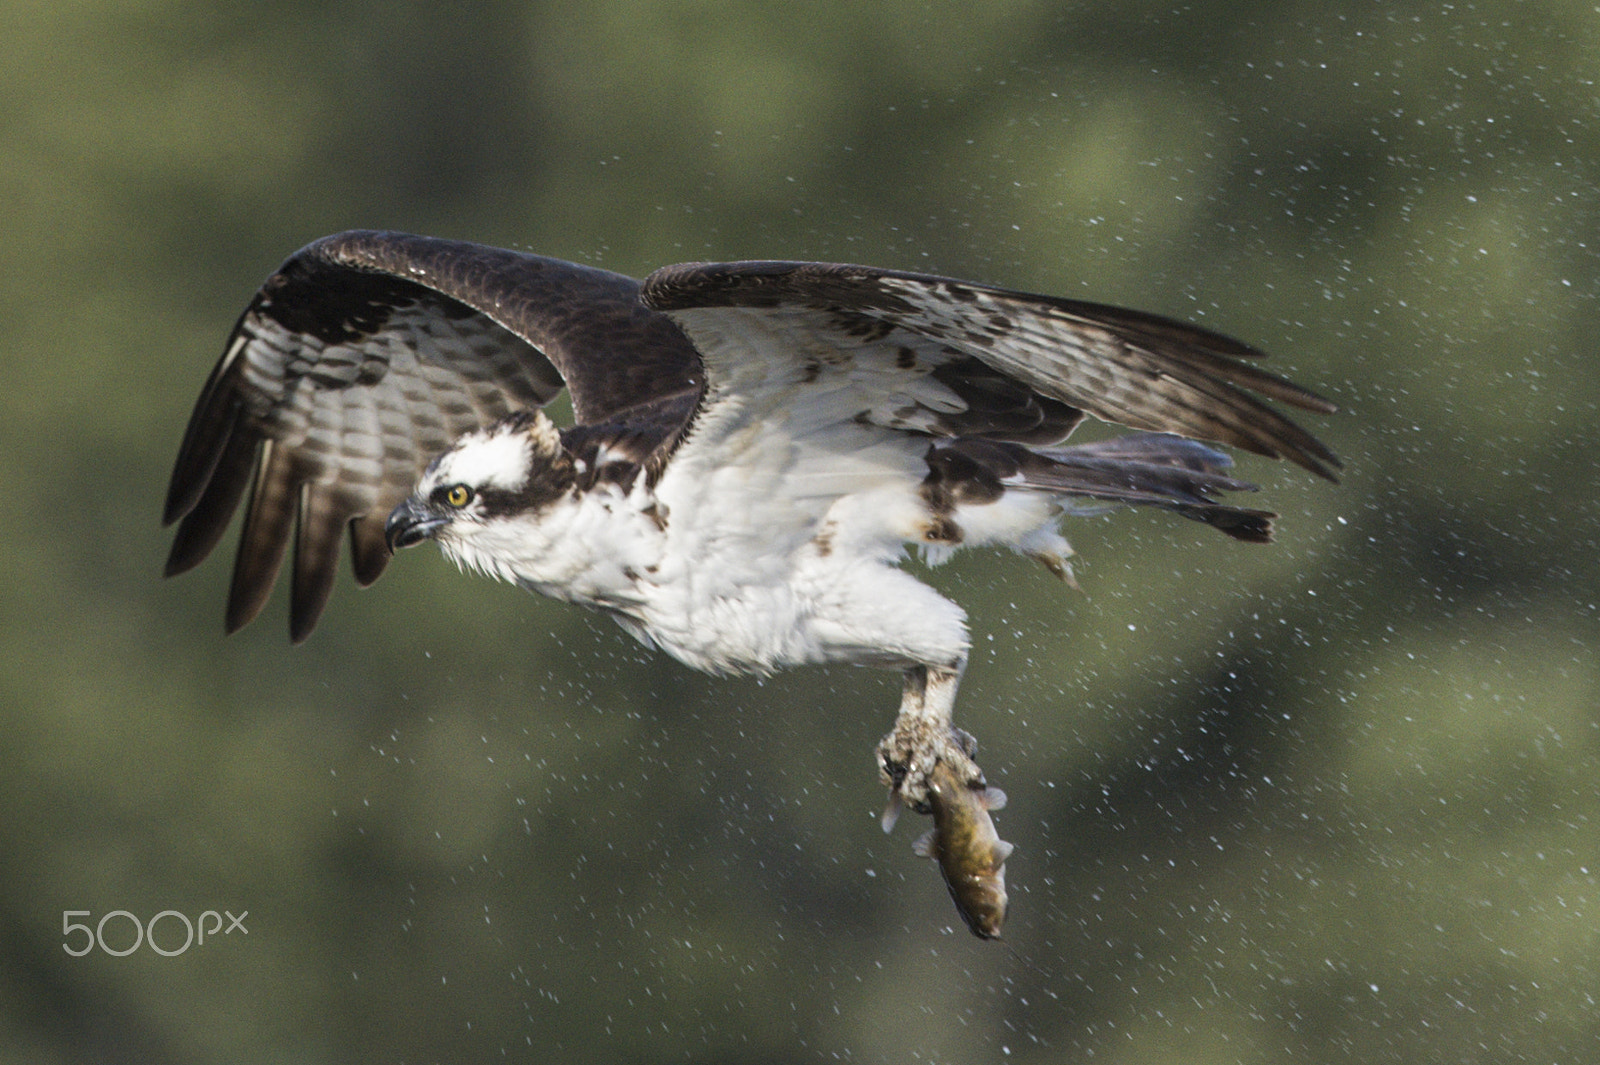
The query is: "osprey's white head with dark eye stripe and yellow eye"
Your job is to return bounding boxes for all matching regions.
[384,411,574,558]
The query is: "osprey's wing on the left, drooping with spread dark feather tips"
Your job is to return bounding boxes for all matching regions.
[165,232,699,641]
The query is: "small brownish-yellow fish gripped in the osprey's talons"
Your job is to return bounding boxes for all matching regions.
[912,761,1014,939]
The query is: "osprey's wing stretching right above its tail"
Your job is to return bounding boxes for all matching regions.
[643,262,1339,480]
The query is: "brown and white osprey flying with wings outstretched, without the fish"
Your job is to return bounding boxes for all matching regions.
[165,232,1339,812]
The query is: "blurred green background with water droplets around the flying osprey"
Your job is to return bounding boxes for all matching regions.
[0,0,1600,1063]
